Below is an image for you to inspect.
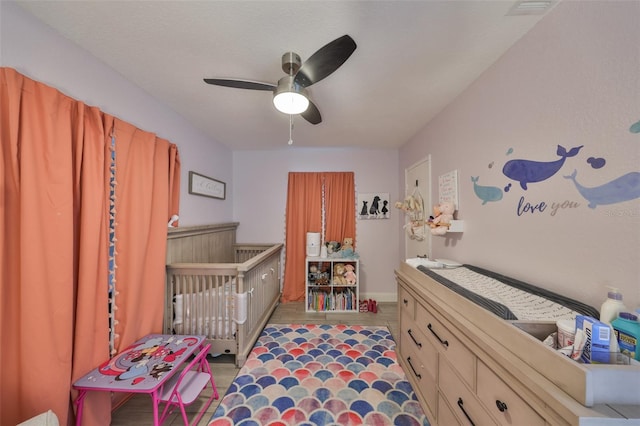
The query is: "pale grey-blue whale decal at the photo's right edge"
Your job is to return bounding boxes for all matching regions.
[565,170,640,209]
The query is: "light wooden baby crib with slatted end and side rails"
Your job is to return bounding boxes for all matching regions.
[164,244,282,365]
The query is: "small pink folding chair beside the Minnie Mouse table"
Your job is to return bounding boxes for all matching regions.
[157,344,218,425]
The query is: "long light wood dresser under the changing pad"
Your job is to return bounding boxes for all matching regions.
[395,262,640,426]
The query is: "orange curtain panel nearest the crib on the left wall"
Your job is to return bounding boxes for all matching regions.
[105,119,180,351]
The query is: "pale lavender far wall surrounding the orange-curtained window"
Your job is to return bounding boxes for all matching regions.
[233,148,403,301]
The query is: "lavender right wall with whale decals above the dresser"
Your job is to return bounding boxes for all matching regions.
[400,1,640,308]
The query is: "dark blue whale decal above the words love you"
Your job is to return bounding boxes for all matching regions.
[502,145,584,191]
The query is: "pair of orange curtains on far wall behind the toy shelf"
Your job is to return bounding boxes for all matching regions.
[281,172,356,302]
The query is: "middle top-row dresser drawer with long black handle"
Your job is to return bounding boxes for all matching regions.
[416,304,475,389]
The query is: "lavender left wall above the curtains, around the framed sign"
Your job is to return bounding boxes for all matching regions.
[0,1,233,226]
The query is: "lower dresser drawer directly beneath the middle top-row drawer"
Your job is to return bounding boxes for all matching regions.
[438,361,496,426]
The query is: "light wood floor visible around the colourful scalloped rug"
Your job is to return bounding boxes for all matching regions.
[111,302,398,426]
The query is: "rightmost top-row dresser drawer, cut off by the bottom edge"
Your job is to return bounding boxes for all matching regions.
[477,361,545,426]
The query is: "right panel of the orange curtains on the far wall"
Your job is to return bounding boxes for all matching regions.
[323,172,356,250]
